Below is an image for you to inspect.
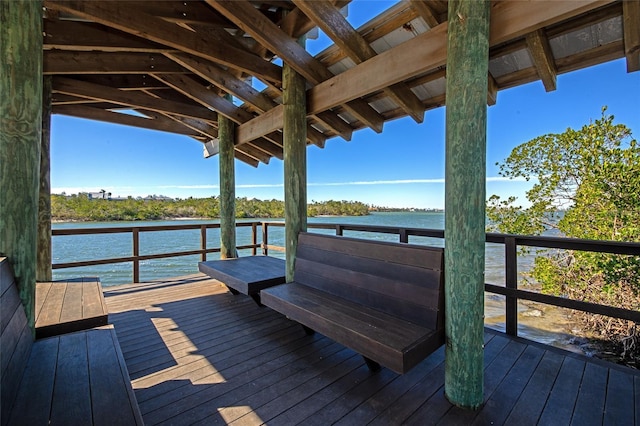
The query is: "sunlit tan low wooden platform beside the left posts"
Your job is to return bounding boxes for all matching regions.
[36,277,109,339]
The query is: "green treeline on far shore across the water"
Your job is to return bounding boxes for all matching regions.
[51,193,369,222]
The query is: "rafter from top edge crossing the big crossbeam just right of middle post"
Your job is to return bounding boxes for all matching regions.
[206,0,384,133]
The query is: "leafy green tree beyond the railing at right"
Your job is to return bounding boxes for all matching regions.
[487,107,640,364]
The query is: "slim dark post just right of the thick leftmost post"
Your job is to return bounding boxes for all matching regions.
[36,75,53,281]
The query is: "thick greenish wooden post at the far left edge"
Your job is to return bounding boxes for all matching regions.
[0,0,42,330]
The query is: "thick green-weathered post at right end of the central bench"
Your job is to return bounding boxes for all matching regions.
[445,0,490,409]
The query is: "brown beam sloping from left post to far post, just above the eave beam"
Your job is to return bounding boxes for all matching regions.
[53,77,218,121]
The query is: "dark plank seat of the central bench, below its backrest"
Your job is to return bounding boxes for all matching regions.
[262,282,444,373]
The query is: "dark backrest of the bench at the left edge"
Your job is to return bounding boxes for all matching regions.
[0,257,33,425]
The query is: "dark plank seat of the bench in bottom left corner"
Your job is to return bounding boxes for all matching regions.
[8,325,144,425]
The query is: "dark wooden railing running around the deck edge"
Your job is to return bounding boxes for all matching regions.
[52,221,640,335]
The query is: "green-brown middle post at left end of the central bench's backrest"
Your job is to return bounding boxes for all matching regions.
[282,60,307,282]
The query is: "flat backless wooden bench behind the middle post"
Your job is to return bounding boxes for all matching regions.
[198,256,285,306]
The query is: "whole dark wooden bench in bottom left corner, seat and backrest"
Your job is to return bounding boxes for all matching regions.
[0,257,143,426]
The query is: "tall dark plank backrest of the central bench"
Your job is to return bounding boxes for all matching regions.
[294,232,444,330]
